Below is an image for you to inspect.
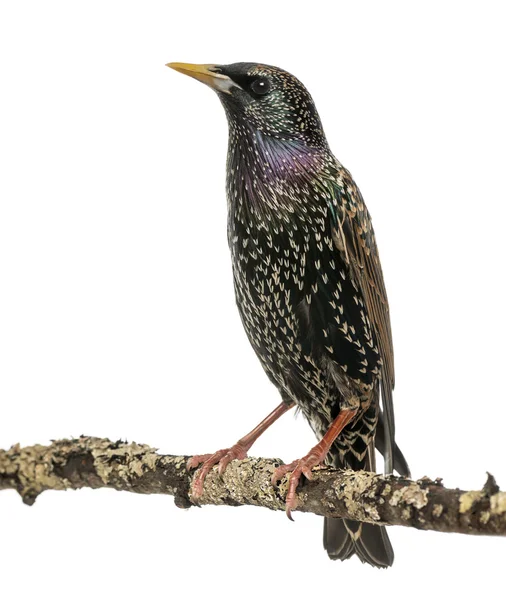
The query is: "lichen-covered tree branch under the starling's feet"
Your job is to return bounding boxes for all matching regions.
[0,437,506,535]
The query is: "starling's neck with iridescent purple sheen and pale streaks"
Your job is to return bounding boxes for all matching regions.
[227,126,334,226]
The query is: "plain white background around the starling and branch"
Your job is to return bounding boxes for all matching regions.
[0,0,506,600]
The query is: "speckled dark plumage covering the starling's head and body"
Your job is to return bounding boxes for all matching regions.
[221,65,393,468]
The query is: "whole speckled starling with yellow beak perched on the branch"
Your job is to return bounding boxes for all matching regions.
[168,63,409,567]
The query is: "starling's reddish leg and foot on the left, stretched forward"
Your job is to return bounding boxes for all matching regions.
[186,402,295,499]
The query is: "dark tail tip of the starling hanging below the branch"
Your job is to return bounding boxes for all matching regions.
[323,517,394,569]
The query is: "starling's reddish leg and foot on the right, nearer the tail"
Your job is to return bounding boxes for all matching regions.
[272,408,357,521]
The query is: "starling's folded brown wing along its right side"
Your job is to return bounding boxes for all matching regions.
[327,165,395,472]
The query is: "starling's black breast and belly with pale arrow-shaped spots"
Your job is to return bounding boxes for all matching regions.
[227,149,380,407]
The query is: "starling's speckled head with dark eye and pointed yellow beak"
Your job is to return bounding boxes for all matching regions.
[167,63,327,149]
